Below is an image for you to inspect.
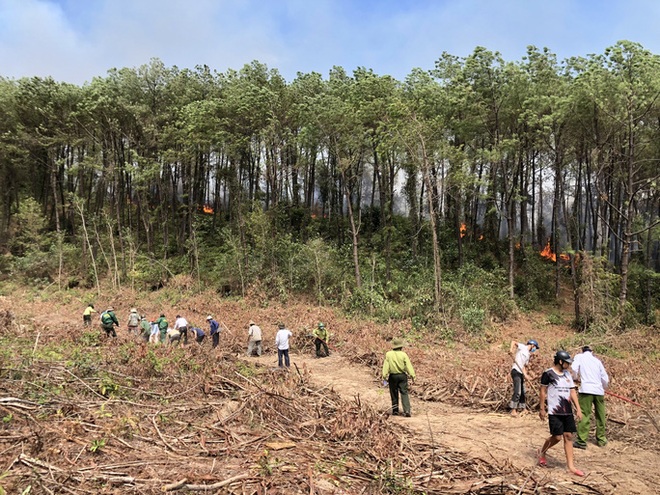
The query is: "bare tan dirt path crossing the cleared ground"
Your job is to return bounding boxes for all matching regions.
[250,354,660,495]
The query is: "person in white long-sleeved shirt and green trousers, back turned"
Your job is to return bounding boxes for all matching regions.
[571,345,610,449]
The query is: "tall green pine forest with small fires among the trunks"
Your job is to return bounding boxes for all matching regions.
[0,41,660,333]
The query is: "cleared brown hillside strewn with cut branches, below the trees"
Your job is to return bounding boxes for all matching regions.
[0,291,660,494]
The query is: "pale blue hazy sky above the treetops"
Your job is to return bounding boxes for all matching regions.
[0,0,660,85]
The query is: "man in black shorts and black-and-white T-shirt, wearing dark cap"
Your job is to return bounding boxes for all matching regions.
[537,351,584,476]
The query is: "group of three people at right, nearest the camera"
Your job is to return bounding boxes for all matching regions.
[509,340,610,476]
